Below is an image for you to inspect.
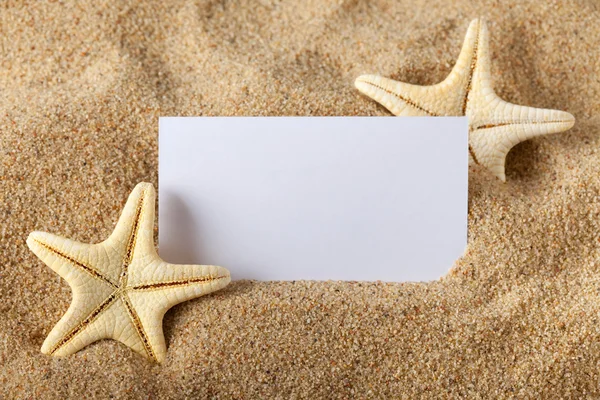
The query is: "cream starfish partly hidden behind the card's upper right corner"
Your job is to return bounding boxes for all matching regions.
[355,19,575,181]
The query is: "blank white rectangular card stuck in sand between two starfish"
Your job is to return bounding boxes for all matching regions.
[159,117,468,281]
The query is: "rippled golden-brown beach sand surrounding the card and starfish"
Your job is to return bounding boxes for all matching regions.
[0,0,600,399]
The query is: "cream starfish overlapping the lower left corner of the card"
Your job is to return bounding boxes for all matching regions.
[27,183,230,363]
